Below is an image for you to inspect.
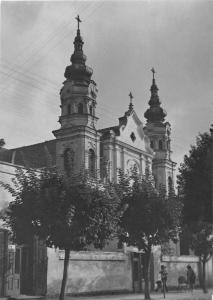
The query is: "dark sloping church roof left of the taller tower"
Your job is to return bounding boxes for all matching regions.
[0,140,56,168]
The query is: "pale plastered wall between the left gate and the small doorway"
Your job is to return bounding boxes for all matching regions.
[47,248,132,295]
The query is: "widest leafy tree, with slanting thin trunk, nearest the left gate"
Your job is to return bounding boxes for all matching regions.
[1,168,119,300]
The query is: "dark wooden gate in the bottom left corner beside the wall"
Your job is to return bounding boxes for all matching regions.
[0,234,47,297]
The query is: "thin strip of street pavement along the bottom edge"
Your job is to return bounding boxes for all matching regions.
[60,290,213,300]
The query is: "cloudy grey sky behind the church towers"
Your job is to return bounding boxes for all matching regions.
[0,0,213,171]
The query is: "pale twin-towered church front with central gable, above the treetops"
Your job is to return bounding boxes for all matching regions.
[53,18,176,186]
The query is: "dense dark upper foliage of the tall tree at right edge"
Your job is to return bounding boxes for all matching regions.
[178,133,212,224]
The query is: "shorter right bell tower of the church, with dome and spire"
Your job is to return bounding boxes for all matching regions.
[144,68,176,190]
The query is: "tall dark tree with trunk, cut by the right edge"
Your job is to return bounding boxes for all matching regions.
[178,133,213,292]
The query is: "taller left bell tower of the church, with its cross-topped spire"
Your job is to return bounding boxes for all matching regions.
[53,16,100,175]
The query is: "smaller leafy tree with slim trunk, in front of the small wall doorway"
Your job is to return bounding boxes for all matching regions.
[117,169,182,299]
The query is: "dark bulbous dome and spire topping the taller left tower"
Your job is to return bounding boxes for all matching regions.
[64,16,93,86]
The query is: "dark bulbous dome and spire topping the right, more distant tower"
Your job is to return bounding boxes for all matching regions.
[144,68,167,122]
